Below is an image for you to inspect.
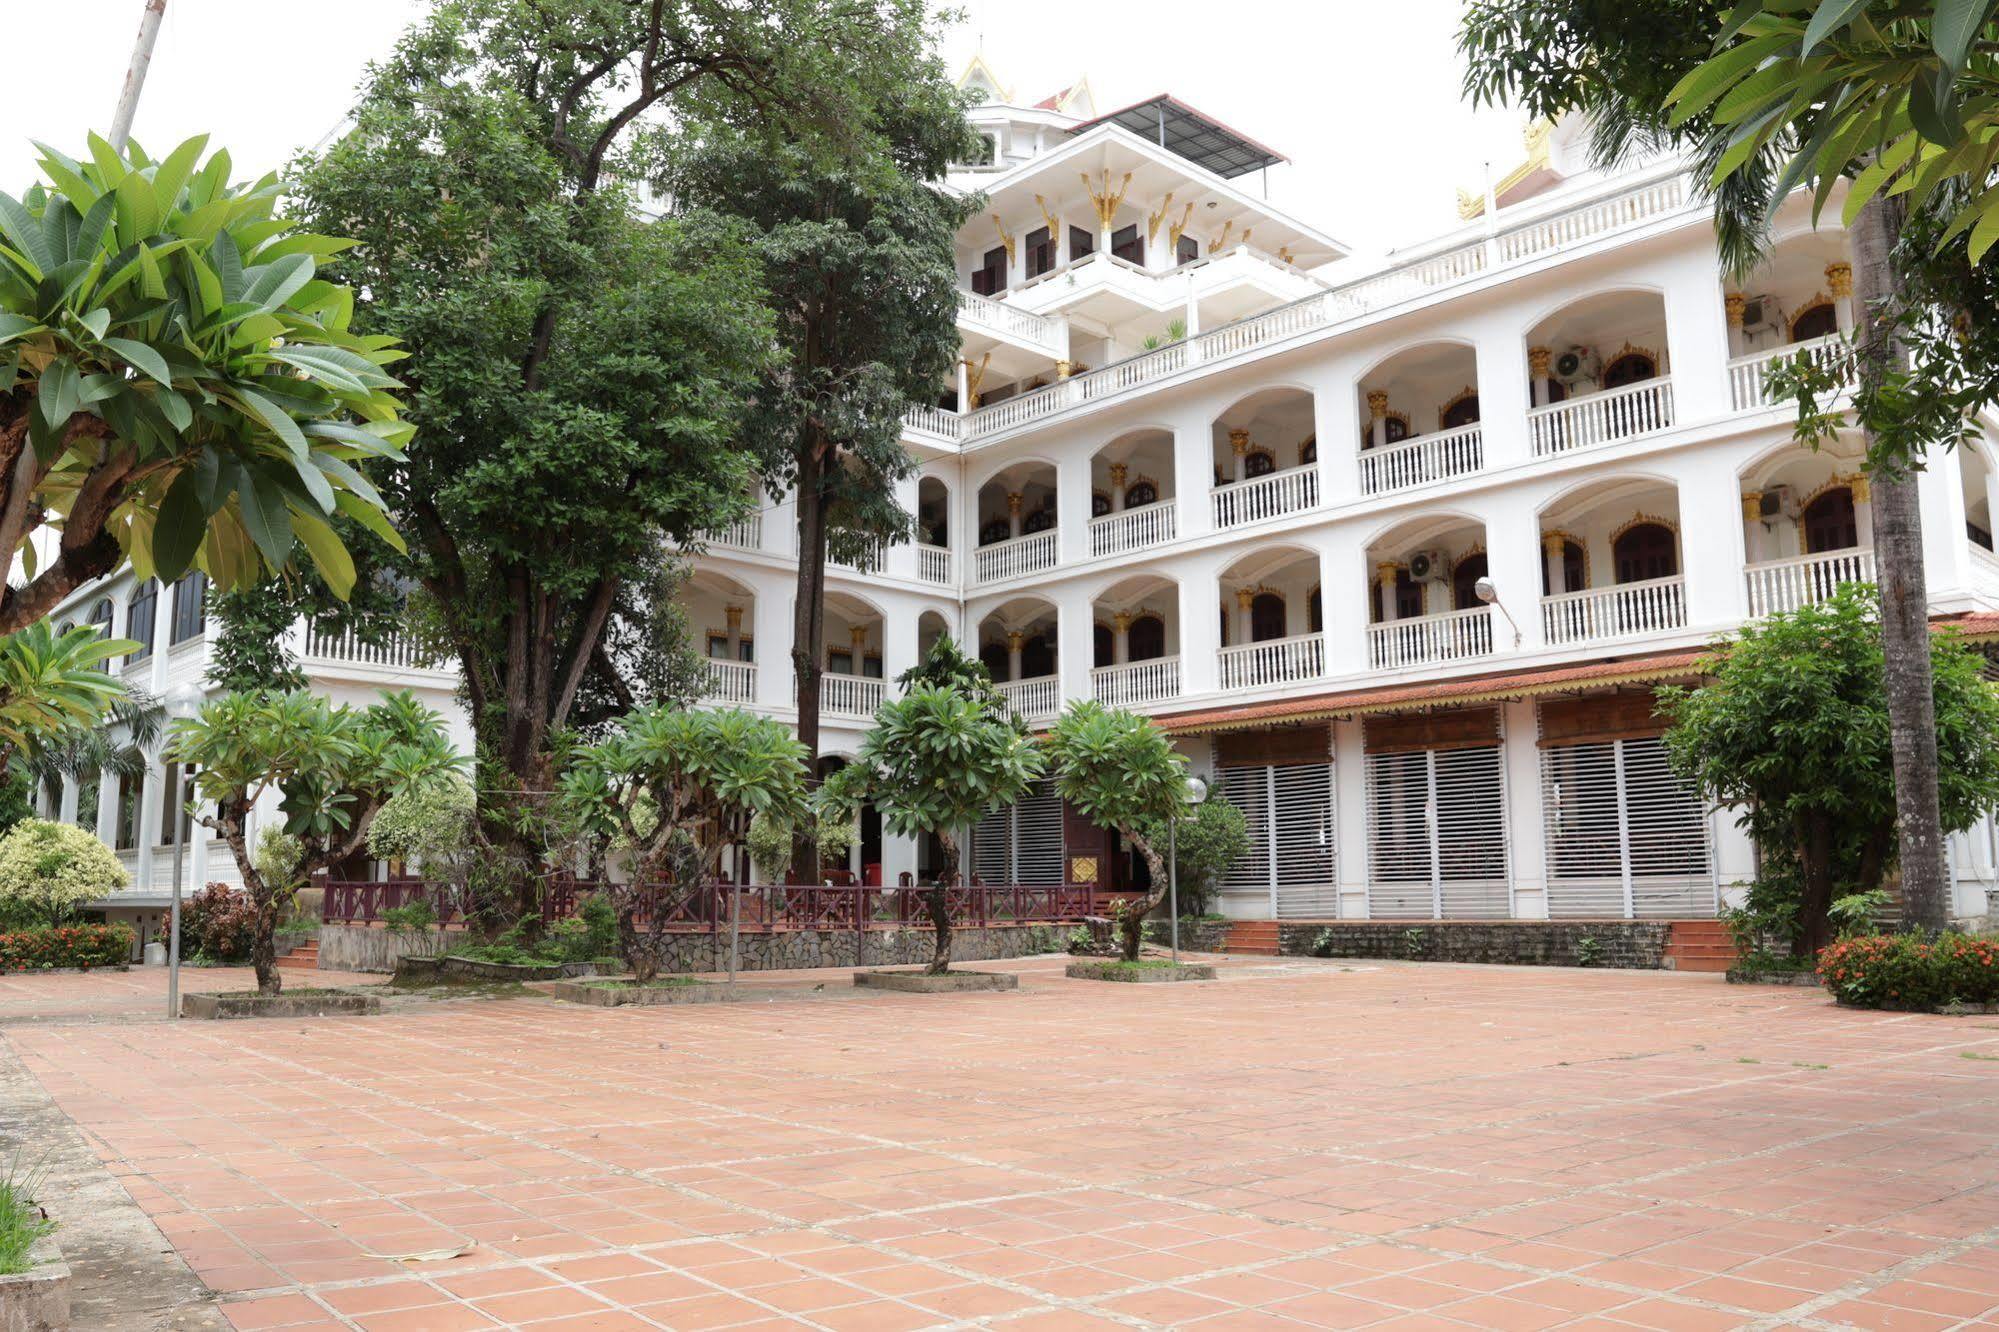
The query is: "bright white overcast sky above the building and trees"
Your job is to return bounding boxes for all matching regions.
[0,0,1521,254]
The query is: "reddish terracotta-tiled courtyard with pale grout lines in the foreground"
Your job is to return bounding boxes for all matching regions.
[0,960,1999,1332]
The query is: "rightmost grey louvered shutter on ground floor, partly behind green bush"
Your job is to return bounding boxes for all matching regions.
[1541,736,1715,920]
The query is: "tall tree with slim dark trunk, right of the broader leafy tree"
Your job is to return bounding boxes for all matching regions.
[672,80,978,882]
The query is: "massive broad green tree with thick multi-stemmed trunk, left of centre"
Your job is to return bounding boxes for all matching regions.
[298,0,955,910]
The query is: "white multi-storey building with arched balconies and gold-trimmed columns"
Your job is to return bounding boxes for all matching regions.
[44,60,1999,926]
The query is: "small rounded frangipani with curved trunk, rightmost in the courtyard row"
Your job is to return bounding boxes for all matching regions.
[1043,702,1187,962]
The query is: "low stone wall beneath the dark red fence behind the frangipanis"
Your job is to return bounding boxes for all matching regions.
[320,924,1069,972]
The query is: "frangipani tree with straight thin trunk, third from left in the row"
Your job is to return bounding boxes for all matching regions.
[818,684,1041,974]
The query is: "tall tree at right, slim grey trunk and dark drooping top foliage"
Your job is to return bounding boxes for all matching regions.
[1459,0,1949,926]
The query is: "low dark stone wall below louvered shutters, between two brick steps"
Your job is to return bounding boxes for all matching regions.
[1277,920,1671,970]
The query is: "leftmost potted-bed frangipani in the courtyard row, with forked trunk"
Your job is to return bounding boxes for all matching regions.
[166,692,466,994]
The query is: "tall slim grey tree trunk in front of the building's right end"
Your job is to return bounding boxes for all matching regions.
[1851,196,1951,930]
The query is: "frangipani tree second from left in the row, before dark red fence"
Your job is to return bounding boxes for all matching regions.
[558,704,808,984]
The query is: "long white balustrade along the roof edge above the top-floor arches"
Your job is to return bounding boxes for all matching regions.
[912,164,1689,440]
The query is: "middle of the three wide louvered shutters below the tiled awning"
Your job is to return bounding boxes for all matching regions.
[1367,746,1511,920]
